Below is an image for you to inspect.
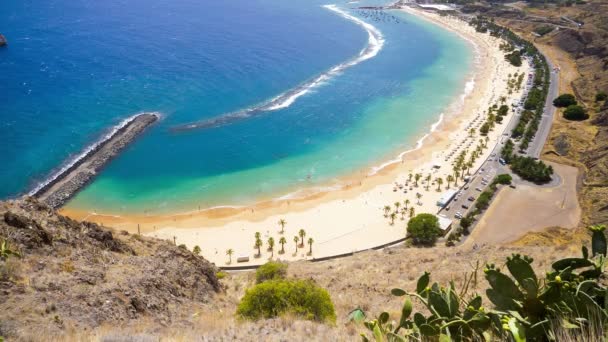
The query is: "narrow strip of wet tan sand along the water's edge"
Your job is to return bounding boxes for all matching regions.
[62,9,483,224]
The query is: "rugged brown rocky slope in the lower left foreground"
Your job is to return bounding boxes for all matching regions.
[0,199,221,340]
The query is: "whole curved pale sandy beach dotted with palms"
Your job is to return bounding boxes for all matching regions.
[61,8,530,266]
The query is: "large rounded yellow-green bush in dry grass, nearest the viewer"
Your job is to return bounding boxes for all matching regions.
[237,279,336,323]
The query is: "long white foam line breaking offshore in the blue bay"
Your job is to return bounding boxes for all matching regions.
[172,5,385,131]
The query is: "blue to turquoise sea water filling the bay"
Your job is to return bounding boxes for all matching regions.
[0,0,472,213]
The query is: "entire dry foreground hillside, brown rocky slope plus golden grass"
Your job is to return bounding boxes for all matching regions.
[0,196,581,341]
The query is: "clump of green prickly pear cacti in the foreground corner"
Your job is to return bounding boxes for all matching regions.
[361,225,608,342]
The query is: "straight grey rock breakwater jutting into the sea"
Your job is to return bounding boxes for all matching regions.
[29,113,160,208]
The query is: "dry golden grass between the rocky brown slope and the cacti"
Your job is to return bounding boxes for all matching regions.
[34,229,587,341]
